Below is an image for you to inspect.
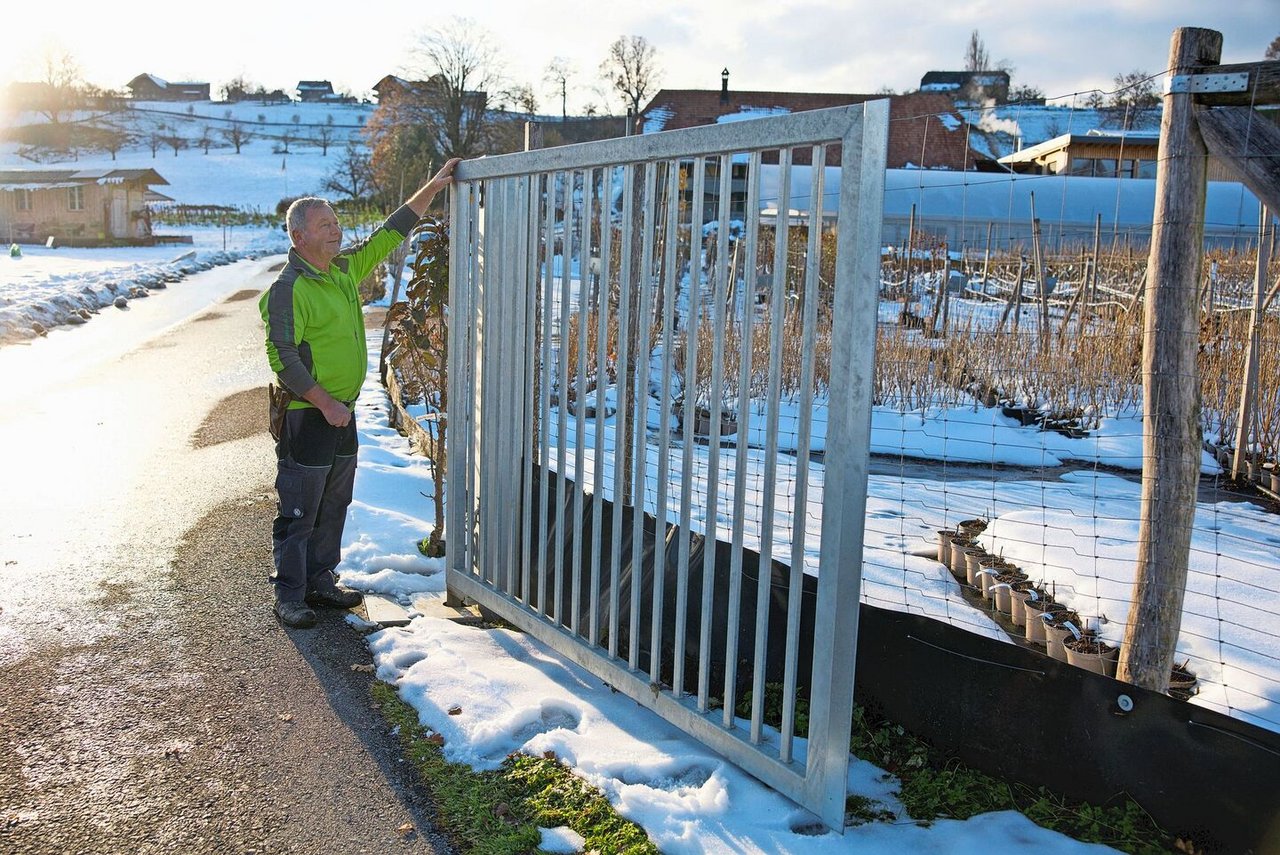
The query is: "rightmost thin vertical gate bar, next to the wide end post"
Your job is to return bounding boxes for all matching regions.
[778,146,827,763]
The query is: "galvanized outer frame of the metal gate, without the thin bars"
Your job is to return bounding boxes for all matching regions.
[445,100,888,833]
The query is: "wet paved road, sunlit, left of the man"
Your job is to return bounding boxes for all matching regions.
[0,261,447,854]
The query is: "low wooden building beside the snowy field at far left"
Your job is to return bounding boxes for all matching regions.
[0,169,169,246]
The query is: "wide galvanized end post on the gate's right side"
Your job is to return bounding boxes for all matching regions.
[805,100,888,828]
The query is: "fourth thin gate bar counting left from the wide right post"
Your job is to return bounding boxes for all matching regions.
[698,155,741,713]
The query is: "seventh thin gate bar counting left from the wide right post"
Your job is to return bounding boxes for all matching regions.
[627,161,658,671]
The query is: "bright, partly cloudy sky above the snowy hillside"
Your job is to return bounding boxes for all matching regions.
[0,0,1280,111]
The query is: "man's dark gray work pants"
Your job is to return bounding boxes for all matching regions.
[271,407,357,602]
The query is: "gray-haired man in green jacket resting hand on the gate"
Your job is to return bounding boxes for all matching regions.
[259,159,458,627]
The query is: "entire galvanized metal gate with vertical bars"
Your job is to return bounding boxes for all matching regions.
[447,101,888,829]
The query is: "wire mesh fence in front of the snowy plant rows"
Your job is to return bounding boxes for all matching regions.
[432,68,1280,762]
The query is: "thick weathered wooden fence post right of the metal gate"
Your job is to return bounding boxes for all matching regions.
[1117,27,1222,692]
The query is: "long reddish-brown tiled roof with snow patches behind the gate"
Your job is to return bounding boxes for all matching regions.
[640,90,989,169]
